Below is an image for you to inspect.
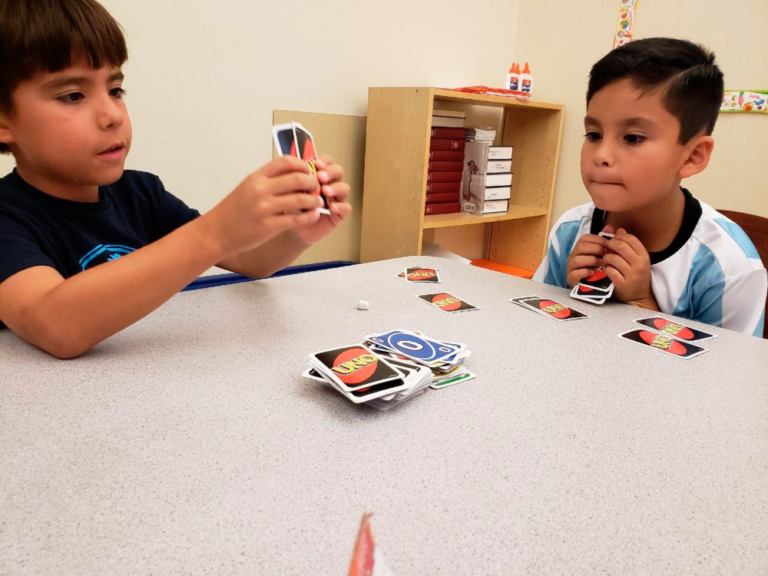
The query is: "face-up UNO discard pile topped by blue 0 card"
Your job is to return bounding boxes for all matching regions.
[366,330,475,390]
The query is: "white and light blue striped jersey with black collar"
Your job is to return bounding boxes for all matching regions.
[533,189,768,336]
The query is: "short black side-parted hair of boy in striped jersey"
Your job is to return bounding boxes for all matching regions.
[587,38,723,144]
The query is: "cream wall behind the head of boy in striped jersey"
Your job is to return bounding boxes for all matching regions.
[515,0,768,223]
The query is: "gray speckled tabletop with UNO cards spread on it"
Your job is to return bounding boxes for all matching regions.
[0,258,768,576]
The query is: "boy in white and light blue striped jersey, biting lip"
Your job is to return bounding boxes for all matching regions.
[534,38,768,336]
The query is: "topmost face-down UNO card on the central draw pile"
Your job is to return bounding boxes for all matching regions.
[310,344,402,392]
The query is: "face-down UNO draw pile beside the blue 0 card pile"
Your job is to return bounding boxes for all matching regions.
[303,344,432,410]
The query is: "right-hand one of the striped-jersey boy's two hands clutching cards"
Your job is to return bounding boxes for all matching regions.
[603,228,658,310]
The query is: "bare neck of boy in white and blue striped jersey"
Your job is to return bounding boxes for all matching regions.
[606,183,685,252]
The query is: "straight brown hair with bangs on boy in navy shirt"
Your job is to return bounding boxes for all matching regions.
[0,0,128,153]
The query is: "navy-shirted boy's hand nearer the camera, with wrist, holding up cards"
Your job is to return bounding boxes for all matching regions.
[202,156,323,255]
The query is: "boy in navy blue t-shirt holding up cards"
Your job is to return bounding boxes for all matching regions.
[0,0,352,358]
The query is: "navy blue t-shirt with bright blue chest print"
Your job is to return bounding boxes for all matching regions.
[0,165,200,284]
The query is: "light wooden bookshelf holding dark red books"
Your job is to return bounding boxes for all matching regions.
[360,87,563,270]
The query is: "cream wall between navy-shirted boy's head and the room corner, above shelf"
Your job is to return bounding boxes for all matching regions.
[0,0,518,216]
